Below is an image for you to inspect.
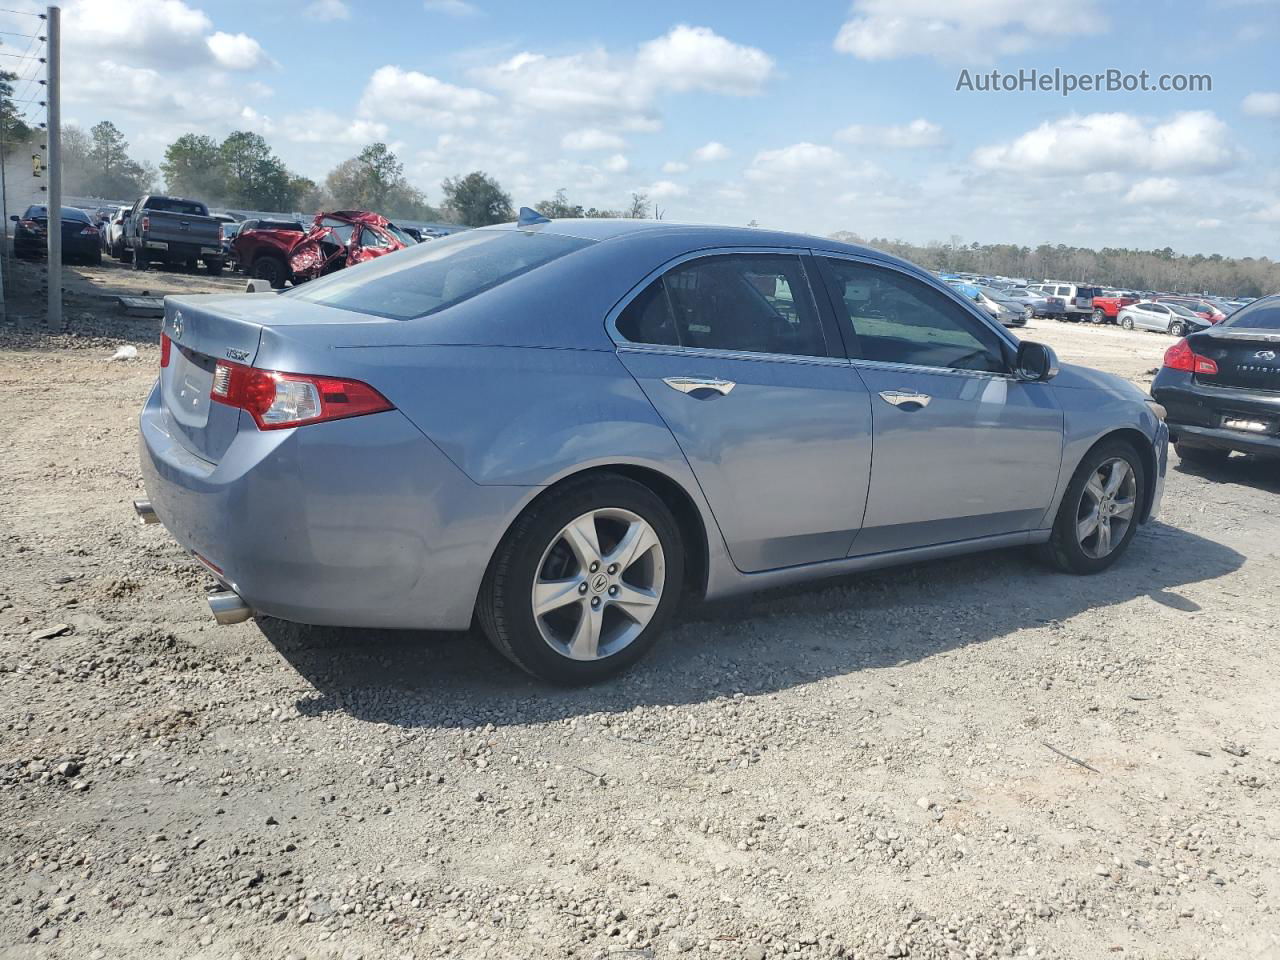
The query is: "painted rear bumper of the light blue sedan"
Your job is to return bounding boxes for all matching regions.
[141,378,531,630]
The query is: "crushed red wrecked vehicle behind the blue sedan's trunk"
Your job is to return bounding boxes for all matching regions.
[232,210,415,288]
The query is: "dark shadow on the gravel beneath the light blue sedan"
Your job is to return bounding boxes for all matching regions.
[257,522,1243,728]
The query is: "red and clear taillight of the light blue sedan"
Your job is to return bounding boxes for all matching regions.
[209,360,393,430]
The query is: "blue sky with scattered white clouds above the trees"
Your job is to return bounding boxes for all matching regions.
[5,0,1280,257]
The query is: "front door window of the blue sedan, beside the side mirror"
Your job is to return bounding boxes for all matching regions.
[826,259,1006,372]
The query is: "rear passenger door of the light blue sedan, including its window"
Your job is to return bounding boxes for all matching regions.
[609,250,872,572]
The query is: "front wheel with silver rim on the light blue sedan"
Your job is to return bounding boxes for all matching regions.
[1042,440,1147,573]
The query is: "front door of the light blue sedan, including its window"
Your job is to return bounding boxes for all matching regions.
[820,255,1064,556]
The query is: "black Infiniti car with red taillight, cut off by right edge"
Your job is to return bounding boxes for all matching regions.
[1151,294,1280,462]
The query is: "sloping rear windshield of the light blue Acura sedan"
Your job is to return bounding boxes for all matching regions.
[284,230,593,320]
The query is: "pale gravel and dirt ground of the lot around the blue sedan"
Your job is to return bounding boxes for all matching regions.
[0,257,1280,960]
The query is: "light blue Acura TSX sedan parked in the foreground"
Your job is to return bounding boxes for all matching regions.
[136,211,1167,684]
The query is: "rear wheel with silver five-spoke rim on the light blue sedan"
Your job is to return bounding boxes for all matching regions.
[476,474,685,685]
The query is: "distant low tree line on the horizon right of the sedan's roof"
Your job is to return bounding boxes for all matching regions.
[832,232,1280,297]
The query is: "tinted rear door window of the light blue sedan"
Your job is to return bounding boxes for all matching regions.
[617,253,827,357]
